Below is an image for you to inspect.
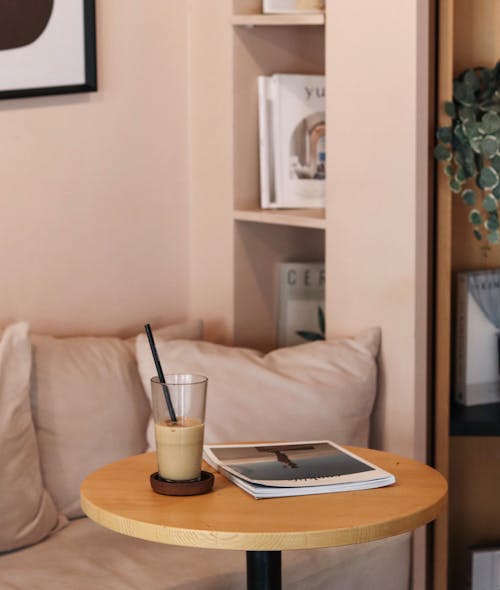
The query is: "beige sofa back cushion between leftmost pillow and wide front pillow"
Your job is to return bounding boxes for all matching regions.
[31,322,200,518]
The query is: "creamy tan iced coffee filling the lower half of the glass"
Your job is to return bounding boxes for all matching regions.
[155,417,204,481]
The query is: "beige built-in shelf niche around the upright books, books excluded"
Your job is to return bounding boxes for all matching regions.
[231,0,327,350]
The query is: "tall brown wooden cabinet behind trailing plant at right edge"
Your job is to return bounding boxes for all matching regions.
[434,0,500,590]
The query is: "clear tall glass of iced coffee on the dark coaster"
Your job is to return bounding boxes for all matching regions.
[151,374,208,482]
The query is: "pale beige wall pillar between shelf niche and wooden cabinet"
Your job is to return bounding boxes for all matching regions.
[326,0,429,459]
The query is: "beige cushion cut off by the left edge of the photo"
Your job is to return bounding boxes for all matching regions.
[0,323,62,551]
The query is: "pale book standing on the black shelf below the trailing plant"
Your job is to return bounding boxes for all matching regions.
[454,269,500,406]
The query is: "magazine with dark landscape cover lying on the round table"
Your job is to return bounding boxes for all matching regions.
[204,440,396,498]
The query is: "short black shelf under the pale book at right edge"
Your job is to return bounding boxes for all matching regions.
[450,402,500,436]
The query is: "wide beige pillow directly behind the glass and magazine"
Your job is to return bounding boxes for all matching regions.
[137,328,380,446]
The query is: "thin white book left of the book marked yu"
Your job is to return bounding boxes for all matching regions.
[257,76,276,209]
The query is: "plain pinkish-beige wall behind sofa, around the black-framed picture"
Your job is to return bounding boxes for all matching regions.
[0,0,189,334]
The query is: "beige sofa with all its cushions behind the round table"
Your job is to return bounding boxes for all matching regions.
[0,322,410,590]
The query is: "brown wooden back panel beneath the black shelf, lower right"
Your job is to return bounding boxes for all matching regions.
[449,436,500,590]
